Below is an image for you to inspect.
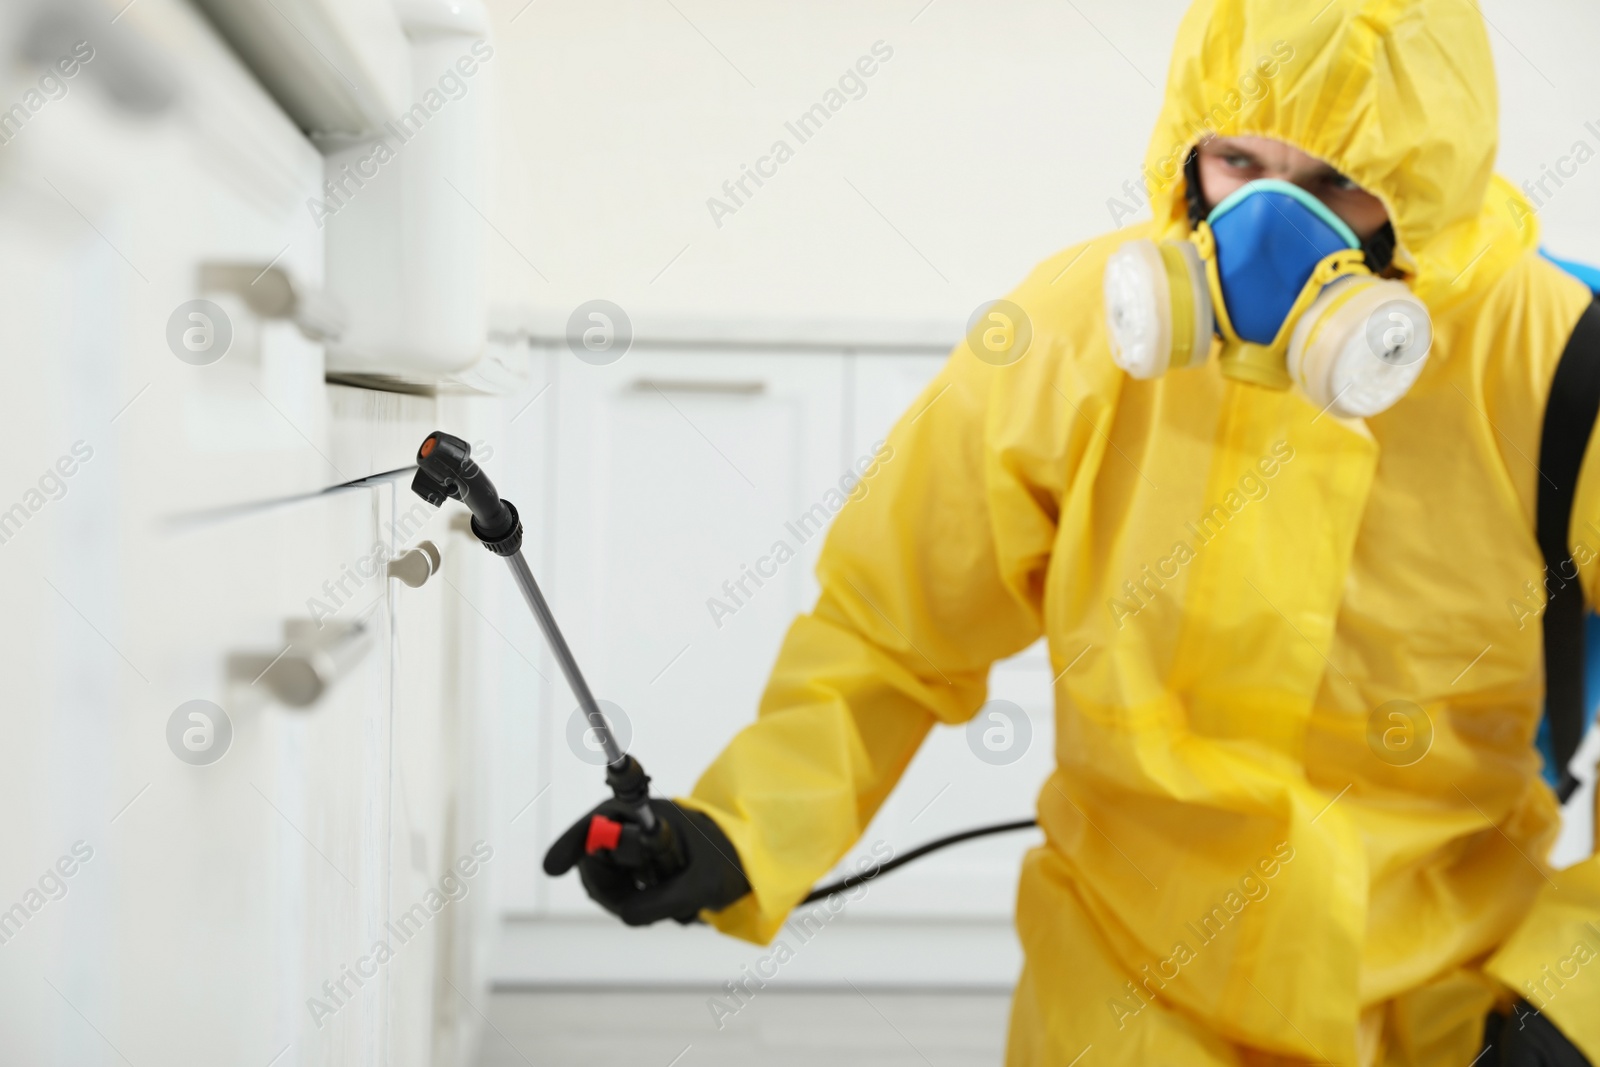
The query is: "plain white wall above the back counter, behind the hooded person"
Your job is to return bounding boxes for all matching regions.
[491,0,1600,325]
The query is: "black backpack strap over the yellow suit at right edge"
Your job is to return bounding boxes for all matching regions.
[1536,302,1600,801]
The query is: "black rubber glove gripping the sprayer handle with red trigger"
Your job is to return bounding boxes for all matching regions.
[544,798,750,926]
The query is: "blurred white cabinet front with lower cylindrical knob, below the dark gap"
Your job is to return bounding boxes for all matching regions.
[0,470,389,1065]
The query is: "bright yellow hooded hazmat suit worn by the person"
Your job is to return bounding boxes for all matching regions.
[683,0,1600,1067]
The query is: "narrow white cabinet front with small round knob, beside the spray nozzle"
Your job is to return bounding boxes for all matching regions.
[381,470,510,1067]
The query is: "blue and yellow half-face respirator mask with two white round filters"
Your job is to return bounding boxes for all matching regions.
[1104,168,1434,418]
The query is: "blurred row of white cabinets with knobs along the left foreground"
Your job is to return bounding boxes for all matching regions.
[0,0,493,1067]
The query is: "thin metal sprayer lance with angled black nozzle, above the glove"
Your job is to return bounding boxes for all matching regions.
[411,432,656,833]
